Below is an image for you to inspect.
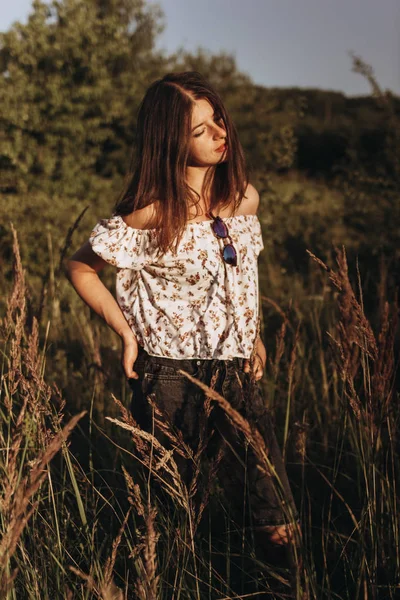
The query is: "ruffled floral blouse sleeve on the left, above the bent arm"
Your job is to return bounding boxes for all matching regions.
[89,215,154,271]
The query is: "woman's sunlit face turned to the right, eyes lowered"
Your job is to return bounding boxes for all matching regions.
[189,98,228,167]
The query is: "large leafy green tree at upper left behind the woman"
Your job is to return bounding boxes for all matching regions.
[0,0,163,197]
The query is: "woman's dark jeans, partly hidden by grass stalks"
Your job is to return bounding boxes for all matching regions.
[130,348,298,527]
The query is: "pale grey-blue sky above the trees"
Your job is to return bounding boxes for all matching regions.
[0,0,400,96]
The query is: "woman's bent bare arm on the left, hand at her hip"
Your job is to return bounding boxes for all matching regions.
[67,242,138,379]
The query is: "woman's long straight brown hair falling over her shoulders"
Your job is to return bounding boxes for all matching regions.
[115,71,248,253]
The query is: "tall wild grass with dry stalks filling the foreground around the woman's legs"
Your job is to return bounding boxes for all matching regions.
[0,221,400,600]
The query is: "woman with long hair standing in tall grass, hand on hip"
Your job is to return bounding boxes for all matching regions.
[69,72,297,580]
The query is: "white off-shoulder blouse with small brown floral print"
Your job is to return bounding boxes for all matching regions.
[90,215,264,359]
